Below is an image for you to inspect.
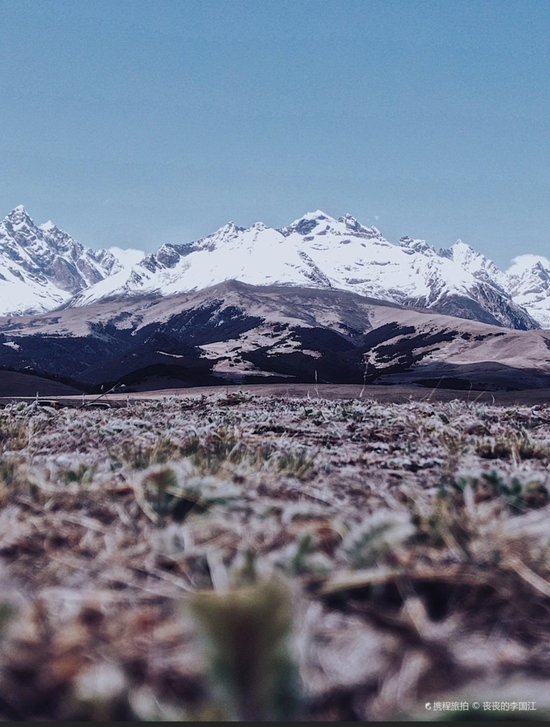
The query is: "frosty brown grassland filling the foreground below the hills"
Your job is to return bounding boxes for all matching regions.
[0,394,550,720]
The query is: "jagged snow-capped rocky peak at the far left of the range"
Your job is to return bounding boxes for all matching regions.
[0,206,142,315]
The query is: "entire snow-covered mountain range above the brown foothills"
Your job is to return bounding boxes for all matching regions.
[0,206,550,330]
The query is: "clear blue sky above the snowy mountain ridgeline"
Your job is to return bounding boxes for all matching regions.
[0,0,550,266]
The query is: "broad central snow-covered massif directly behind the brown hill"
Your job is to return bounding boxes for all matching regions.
[73,210,537,329]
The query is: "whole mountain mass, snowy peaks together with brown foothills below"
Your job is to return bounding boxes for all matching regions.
[0,207,550,395]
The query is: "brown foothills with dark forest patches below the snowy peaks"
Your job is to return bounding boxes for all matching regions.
[0,282,550,390]
